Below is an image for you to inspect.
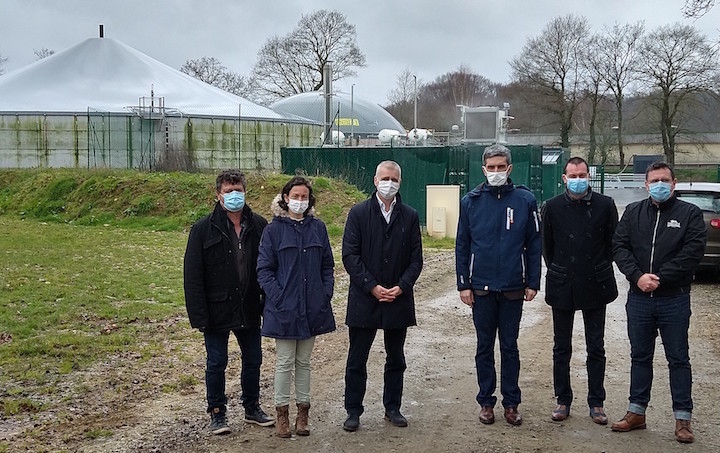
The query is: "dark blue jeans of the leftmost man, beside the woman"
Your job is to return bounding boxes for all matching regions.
[205,328,262,412]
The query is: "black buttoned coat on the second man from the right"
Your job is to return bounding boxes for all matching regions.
[541,191,618,310]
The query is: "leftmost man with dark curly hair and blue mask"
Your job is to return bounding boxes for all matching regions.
[184,170,275,434]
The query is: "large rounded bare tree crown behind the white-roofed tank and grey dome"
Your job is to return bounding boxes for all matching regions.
[252,10,365,101]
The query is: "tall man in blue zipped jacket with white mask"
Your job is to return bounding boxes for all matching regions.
[455,144,541,425]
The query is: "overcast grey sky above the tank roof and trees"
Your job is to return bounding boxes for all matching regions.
[0,0,720,107]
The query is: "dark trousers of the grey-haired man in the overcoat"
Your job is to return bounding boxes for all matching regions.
[345,327,407,416]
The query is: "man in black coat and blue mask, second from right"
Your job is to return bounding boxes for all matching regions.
[542,157,618,425]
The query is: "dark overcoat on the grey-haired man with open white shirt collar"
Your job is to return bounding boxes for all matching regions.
[342,192,423,329]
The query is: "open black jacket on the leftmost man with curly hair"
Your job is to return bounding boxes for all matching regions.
[184,203,267,331]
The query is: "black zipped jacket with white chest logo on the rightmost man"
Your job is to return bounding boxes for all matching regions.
[613,194,707,297]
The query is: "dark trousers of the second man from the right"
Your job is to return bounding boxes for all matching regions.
[552,305,605,408]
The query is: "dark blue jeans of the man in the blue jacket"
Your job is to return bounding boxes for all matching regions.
[473,292,523,407]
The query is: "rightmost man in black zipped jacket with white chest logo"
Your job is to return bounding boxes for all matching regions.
[612,162,707,443]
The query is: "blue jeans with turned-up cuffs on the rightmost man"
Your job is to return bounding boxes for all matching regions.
[625,293,693,420]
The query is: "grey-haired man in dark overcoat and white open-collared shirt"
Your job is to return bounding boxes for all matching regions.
[342,161,423,431]
